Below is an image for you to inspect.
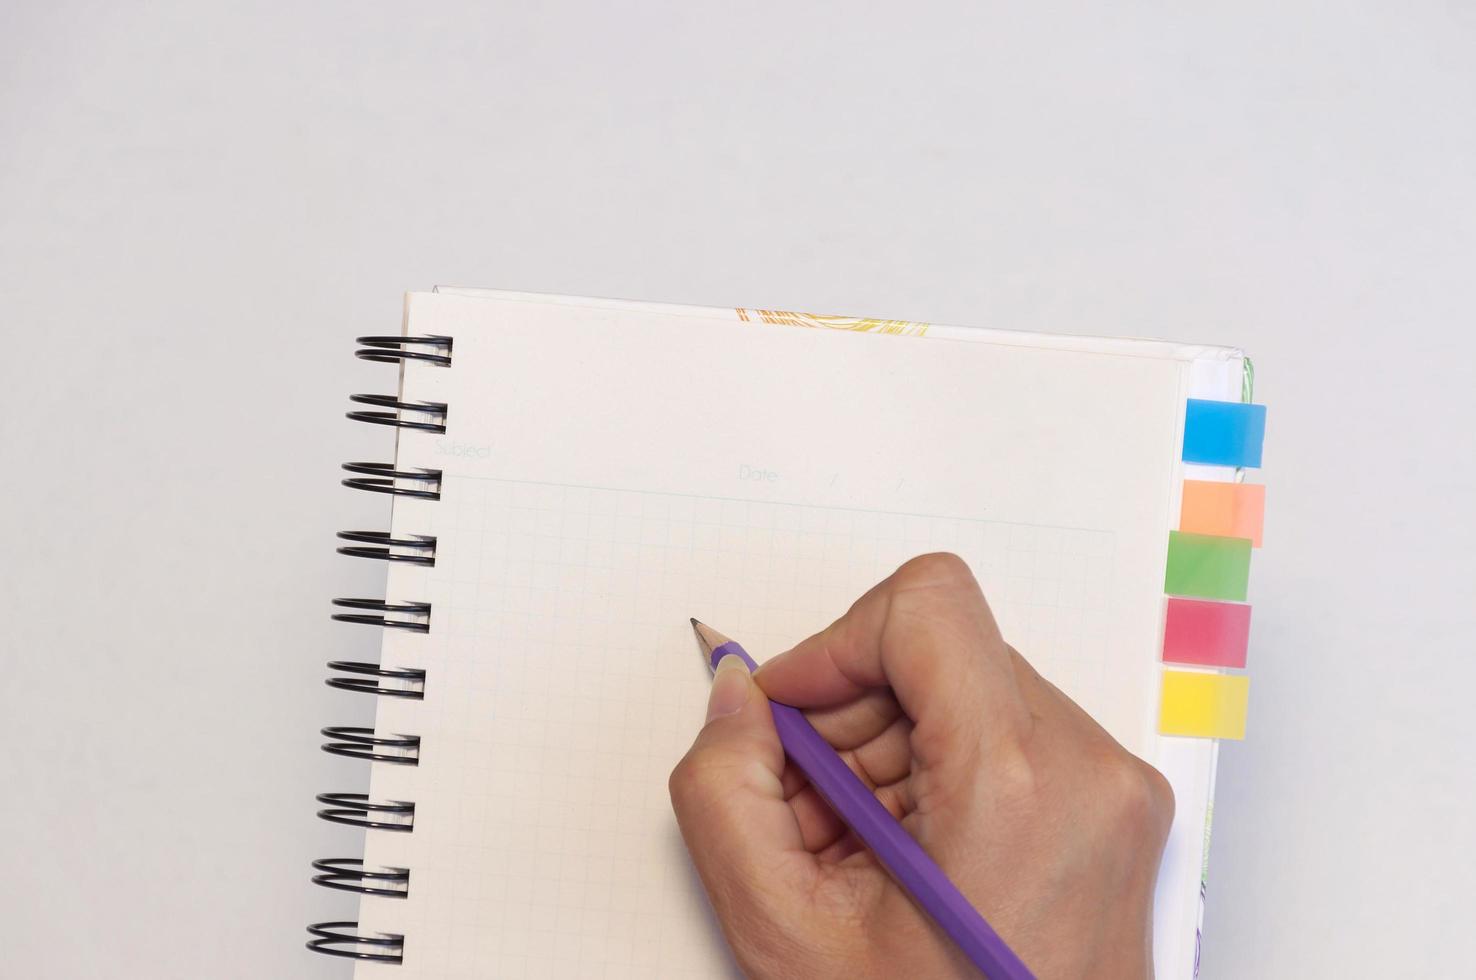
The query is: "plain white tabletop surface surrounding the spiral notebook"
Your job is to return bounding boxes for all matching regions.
[0,3,1476,980]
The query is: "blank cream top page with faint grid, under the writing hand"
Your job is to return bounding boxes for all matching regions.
[360,294,1188,977]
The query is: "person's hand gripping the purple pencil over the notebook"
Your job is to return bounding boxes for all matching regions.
[670,555,1173,980]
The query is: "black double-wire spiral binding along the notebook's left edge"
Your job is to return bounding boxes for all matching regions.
[307,337,452,964]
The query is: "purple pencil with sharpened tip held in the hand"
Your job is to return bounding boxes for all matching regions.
[692,620,1035,980]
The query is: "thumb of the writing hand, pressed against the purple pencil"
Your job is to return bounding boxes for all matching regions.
[669,654,809,928]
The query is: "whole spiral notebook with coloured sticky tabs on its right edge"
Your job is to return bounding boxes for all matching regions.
[308,289,1263,980]
